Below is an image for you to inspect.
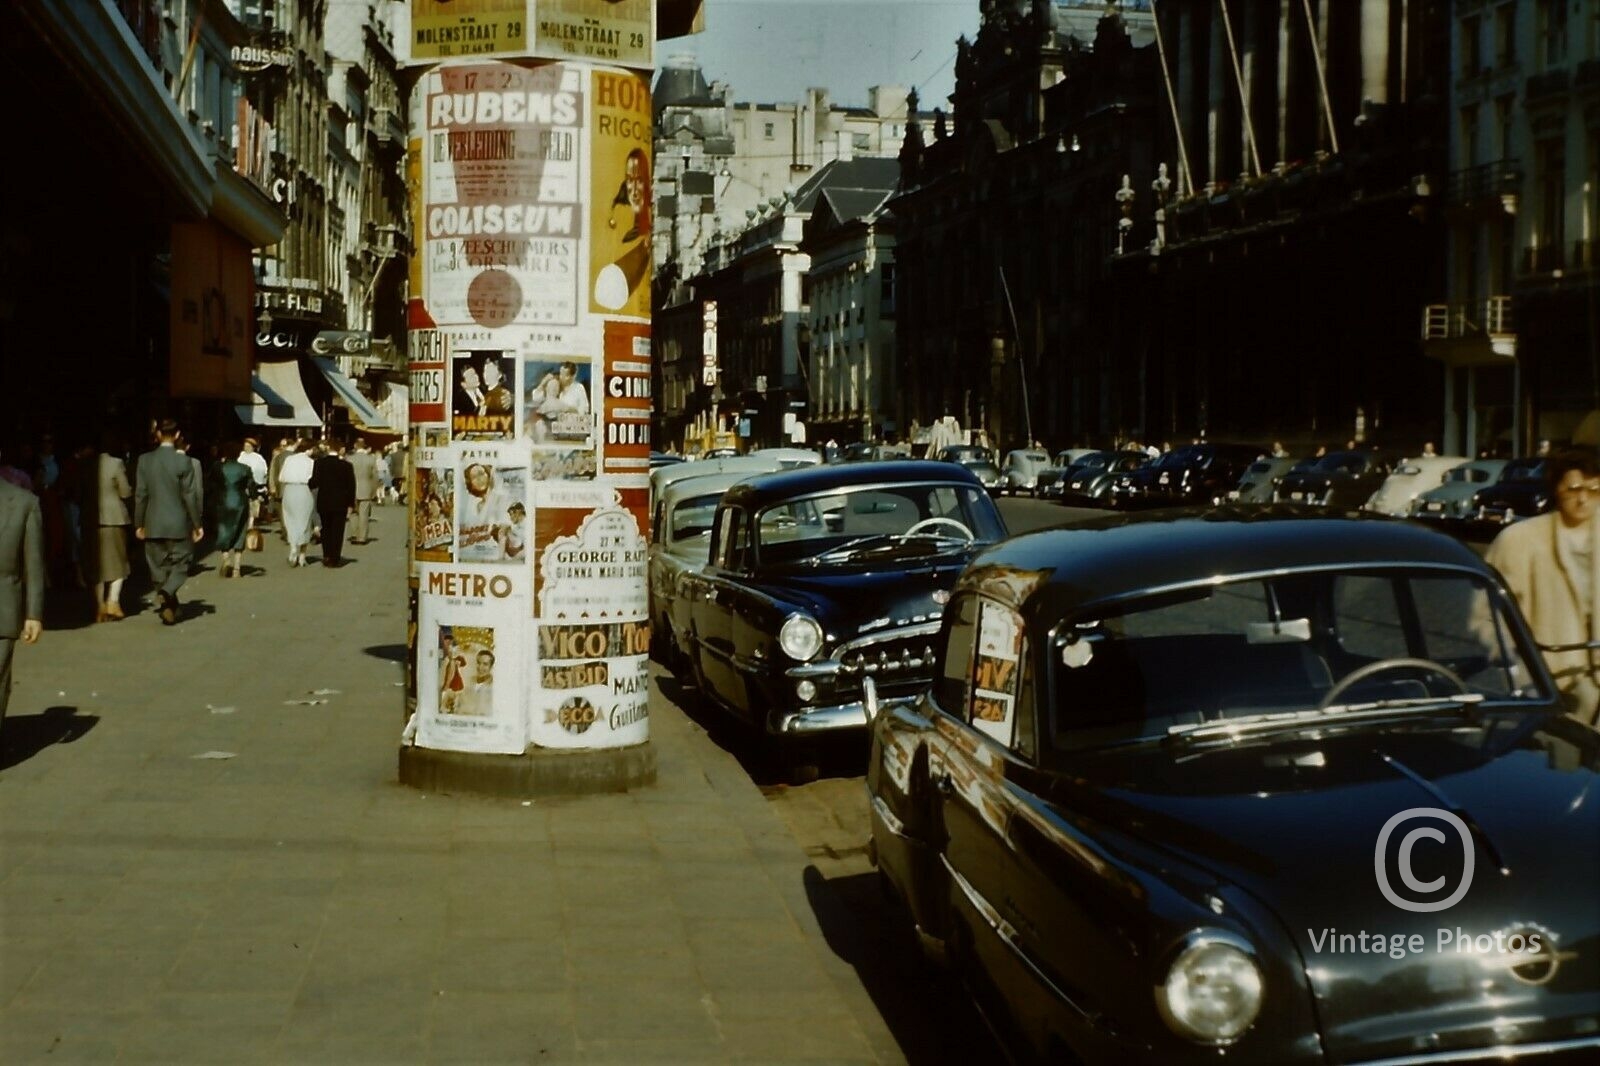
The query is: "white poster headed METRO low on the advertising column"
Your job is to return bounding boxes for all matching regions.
[416,563,528,755]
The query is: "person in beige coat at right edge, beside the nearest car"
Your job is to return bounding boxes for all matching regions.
[1486,448,1600,725]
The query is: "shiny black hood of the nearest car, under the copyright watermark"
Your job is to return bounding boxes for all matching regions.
[1067,714,1600,1061]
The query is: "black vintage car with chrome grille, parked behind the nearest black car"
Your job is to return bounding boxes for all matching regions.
[678,459,1005,776]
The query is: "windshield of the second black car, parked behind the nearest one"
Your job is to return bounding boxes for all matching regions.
[757,482,1005,563]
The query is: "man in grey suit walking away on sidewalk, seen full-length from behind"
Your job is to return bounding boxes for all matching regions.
[133,418,205,626]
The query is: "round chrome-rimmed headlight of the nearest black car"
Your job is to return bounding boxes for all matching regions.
[1155,935,1261,1044]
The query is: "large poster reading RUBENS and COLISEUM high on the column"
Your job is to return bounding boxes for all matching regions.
[419,61,582,330]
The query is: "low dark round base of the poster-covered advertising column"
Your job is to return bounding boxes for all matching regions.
[400,743,656,799]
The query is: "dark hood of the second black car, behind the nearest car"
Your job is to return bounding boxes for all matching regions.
[760,546,984,640]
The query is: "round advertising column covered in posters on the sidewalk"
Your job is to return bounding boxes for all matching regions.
[400,12,654,792]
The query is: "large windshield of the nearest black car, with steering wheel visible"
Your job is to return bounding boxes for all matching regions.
[1051,568,1547,749]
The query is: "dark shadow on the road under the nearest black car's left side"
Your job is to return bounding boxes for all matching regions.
[805,866,1000,1066]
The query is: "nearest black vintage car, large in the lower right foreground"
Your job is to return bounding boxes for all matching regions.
[867,506,1600,1066]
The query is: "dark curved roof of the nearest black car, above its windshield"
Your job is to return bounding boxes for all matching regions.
[957,504,1491,614]
